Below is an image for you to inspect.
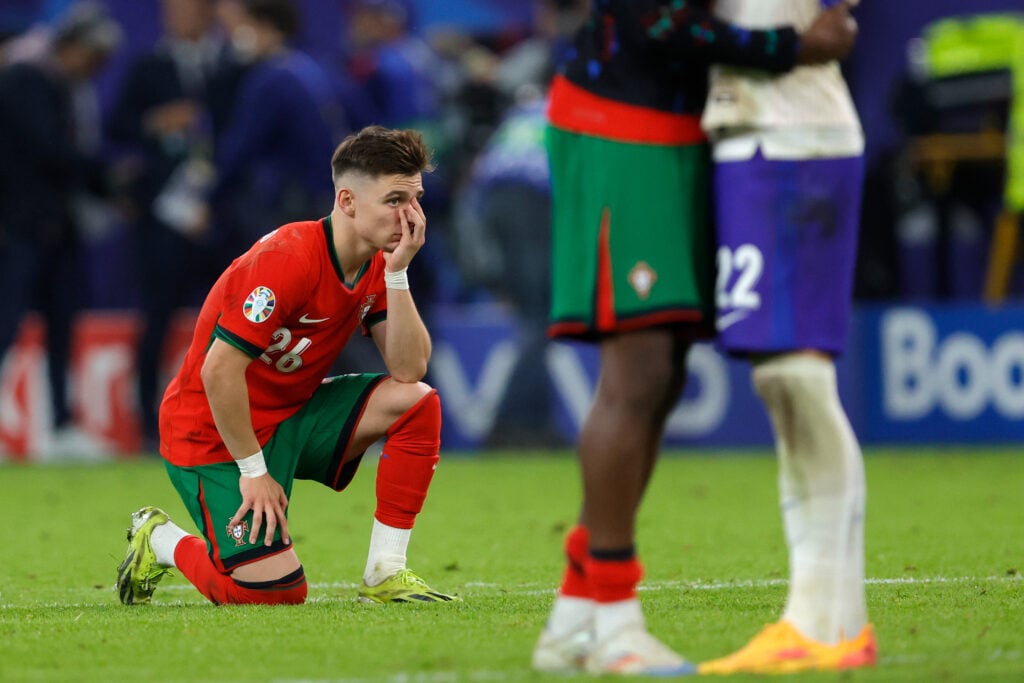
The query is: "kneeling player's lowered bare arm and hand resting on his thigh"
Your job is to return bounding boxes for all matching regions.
[202,339,290,546]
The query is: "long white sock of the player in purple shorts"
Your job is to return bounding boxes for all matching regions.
[754,354,867,643]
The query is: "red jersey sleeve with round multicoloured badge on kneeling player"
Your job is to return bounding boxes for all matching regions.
[213,249,315,358]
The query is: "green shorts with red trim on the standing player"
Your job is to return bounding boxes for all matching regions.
[548,126,715,340]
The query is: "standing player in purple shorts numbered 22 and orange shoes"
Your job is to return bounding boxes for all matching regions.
[700,0,876,674]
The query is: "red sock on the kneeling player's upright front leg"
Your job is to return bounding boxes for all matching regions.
[375,390,441,528]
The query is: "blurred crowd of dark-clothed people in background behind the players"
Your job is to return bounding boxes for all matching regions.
[0,0,1024,454]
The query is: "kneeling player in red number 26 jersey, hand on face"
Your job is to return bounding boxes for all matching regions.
[118,127,454,605]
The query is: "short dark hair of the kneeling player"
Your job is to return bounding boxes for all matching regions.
[331,126,434,182]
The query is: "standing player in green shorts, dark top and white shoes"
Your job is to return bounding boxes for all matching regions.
[532,0,853,675]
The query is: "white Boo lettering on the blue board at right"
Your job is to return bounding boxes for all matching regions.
[880,308,1024,421]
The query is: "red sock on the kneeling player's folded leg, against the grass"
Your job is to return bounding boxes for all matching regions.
[174,536,307,605]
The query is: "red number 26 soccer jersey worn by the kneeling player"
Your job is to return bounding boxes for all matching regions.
[160,218,387,467]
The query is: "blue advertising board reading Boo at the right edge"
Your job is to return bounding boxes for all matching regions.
[855,304,1024,443]
